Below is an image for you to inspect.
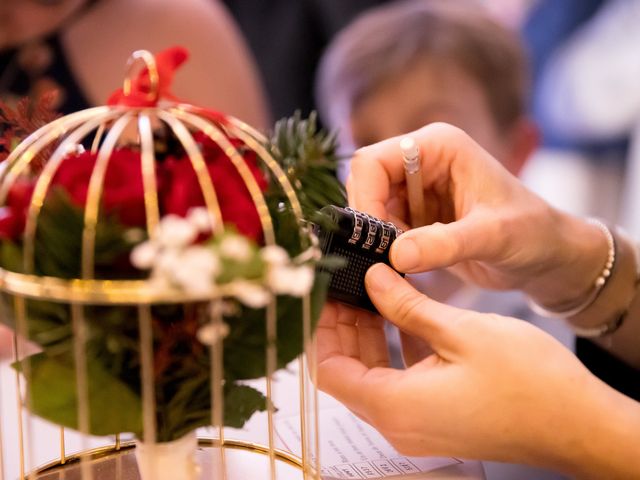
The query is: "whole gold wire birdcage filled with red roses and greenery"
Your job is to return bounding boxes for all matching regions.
[0,51,330,479]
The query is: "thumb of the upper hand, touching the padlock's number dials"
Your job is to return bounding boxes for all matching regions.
[389,214,501,273]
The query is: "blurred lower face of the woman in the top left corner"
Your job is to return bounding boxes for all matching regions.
[0,0,86,48]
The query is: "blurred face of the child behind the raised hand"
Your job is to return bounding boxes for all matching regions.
[350,61,519,171]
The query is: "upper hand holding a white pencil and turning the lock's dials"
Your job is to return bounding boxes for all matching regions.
[347,124,607,306]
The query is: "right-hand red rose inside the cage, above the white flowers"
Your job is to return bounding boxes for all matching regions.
[162,132,267,241]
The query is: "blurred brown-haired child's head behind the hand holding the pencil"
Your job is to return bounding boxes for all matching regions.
[316,0,538,193]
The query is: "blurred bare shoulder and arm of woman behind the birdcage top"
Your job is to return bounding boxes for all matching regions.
[63,0,267,127]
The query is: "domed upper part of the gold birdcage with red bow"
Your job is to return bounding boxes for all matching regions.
[0,48,312,304]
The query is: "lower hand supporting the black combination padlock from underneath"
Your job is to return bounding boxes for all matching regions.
[317,265,633,473]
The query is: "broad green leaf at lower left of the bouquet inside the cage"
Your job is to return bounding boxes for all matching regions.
[21,353,142,436]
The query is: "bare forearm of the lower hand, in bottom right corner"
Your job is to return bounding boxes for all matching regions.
[506,363,640,480]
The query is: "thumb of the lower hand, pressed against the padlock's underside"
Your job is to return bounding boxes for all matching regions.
[365,263,467,356]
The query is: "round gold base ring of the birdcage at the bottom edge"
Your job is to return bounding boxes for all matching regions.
[29,438,318,480]
